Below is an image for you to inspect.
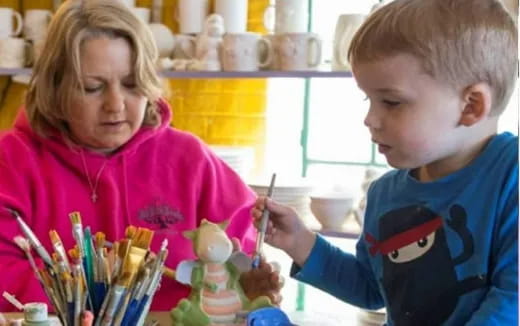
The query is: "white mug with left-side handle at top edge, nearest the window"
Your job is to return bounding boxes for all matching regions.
[264,0,309,34]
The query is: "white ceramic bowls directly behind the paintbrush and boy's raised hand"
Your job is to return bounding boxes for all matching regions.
[249,176,313,222]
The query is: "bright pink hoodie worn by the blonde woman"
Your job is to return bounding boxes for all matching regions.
[0,102,255,311]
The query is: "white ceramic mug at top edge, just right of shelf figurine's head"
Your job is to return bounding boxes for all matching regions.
[215,0,248,33]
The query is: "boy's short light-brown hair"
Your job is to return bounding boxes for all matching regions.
[348,0,518,115]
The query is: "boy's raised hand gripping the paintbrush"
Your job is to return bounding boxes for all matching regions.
[251,196,316,266]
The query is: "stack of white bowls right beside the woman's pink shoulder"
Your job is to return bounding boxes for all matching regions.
[211,146,254,179]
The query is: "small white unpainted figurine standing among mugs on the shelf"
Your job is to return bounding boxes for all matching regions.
[195,14,224,71]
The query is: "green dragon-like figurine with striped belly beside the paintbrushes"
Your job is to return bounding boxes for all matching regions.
[171,219,273,326]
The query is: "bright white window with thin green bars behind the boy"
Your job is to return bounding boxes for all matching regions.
[264,0,519,191]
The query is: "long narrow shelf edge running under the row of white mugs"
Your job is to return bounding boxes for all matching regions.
[0,68,352,79]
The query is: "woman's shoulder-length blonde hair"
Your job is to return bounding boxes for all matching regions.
[25,0,161,136]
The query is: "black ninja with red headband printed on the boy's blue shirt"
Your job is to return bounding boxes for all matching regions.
[366,205,486,326]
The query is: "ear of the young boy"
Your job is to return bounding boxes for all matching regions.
[459,83,492,127]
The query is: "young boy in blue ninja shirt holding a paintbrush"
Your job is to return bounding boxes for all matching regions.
[252,0,518,326]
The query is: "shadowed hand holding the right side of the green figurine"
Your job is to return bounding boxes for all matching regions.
[240,257,283,306]
